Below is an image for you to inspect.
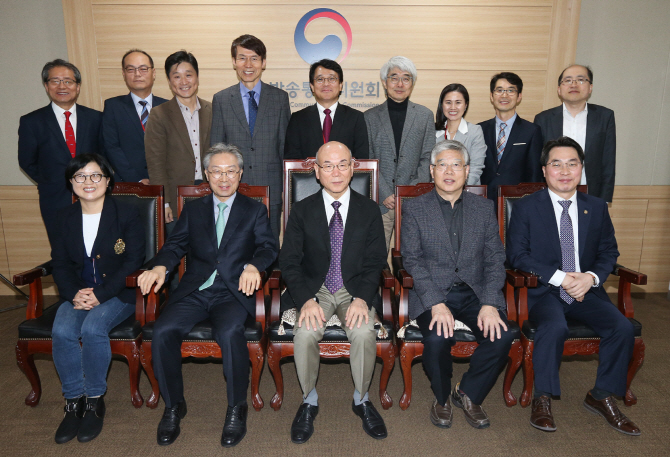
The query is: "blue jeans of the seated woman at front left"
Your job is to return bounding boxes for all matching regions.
[51,297,135,398]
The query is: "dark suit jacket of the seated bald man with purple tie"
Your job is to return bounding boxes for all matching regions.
[279,190,386,310]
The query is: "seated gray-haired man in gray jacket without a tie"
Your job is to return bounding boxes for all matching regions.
[402,140,514,428]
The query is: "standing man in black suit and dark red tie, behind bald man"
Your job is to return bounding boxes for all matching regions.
[284,59,369,159]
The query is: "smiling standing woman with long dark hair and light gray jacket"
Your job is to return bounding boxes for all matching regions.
[435,84,486,185]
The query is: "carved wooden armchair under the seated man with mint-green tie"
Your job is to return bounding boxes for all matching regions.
[135,183,278,411]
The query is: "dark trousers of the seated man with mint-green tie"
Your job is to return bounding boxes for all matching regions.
[151,275,249,408]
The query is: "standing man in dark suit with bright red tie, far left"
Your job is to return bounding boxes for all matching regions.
[19,59,104,243]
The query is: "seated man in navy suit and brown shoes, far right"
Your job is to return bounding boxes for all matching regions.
[507,137,640,435]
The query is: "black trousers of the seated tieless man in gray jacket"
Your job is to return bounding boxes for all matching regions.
[416,284,514,405]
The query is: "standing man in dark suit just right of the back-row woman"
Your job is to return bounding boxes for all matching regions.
[479,72,542,202]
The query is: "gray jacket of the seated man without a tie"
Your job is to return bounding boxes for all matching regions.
[401,190,505,319]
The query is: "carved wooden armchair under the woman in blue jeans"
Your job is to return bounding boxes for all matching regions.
[14,182,165,408]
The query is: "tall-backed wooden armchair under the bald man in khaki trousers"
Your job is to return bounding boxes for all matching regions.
[268,158,396,410]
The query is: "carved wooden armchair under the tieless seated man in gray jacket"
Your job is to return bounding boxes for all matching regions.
[391,183,524,410]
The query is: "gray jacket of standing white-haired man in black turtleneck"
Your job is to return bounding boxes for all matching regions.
[364,101,435,214]
